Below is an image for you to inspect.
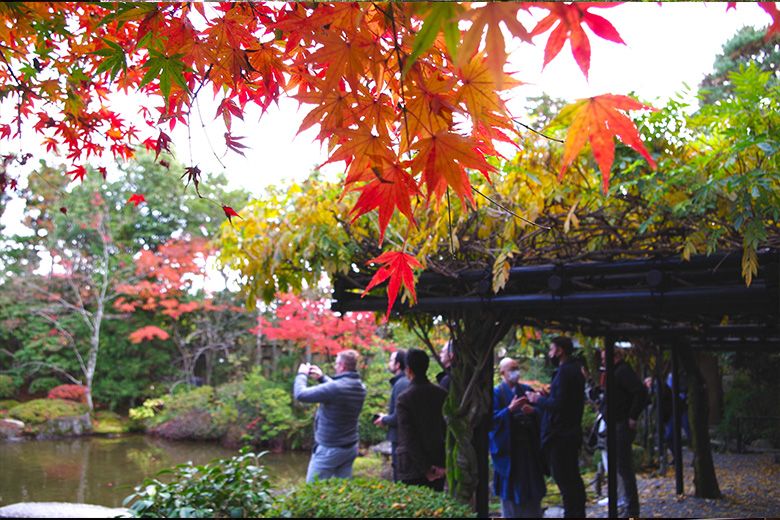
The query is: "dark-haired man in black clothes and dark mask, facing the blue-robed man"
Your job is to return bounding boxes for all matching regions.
[526,336,585,518]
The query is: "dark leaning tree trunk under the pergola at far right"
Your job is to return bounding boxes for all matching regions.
[679,345,722,498]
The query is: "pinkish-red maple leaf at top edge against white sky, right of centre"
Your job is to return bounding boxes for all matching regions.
[531,2,625,78]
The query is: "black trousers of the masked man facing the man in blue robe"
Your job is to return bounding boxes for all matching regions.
[545,437,585,518]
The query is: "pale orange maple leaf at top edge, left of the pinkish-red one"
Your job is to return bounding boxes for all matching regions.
[457,2,531,90]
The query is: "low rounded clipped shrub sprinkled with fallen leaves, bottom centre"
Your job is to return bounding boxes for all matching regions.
[270,478,474,518]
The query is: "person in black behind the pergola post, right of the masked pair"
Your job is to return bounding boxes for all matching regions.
[601,348,647,518]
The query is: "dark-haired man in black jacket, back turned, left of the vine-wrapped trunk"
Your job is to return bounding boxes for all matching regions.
[396,348,447,491]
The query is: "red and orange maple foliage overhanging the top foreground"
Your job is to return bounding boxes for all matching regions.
[0,2,780,310]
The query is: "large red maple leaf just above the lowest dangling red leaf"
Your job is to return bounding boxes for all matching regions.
[351,163,419,244]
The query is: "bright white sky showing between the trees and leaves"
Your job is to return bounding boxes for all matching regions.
[2,2,770,233]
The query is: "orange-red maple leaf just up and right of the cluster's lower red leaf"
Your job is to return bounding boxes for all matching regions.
[411,131,495,200]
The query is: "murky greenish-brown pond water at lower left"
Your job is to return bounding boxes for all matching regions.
[0,435,309,507]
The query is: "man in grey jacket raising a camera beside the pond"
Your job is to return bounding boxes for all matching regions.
[293,350,366,482]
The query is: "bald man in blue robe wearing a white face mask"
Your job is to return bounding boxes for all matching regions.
[490,358,546,518]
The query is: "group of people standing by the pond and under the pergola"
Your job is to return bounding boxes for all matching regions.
[293,336,647,518]
